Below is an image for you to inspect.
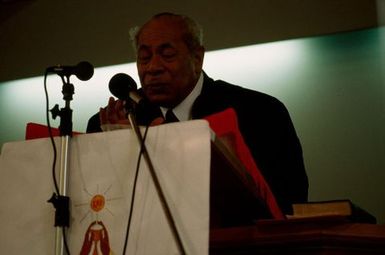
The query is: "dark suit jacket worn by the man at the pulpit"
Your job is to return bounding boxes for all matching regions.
[87,74,308,214]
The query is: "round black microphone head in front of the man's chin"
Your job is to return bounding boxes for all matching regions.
[108,73,136,101]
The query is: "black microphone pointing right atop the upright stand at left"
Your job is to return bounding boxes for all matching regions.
[46,61,94,81]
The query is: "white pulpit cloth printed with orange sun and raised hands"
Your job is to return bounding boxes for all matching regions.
[0,120,210,255]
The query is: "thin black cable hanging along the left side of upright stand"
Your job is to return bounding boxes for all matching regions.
[44,70,70,255]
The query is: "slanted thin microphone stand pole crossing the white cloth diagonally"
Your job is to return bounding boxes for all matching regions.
[127,106,186,254]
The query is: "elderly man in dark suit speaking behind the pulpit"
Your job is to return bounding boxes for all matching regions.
[87,13,308,214]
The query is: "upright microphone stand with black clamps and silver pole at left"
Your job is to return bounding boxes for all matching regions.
[49,76,74,255]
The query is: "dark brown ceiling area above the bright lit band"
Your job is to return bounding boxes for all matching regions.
[0,0,385,81]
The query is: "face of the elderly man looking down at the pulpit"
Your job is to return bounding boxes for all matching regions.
[137,17,203,108]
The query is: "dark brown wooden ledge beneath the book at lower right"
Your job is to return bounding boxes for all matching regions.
[210,216,385,255]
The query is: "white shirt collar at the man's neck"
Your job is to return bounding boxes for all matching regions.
[160,72,203,121]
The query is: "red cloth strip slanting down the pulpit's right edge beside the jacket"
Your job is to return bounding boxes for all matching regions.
[205,108,285,219]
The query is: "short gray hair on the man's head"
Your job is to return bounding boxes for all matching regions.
[130,12,203,52]
